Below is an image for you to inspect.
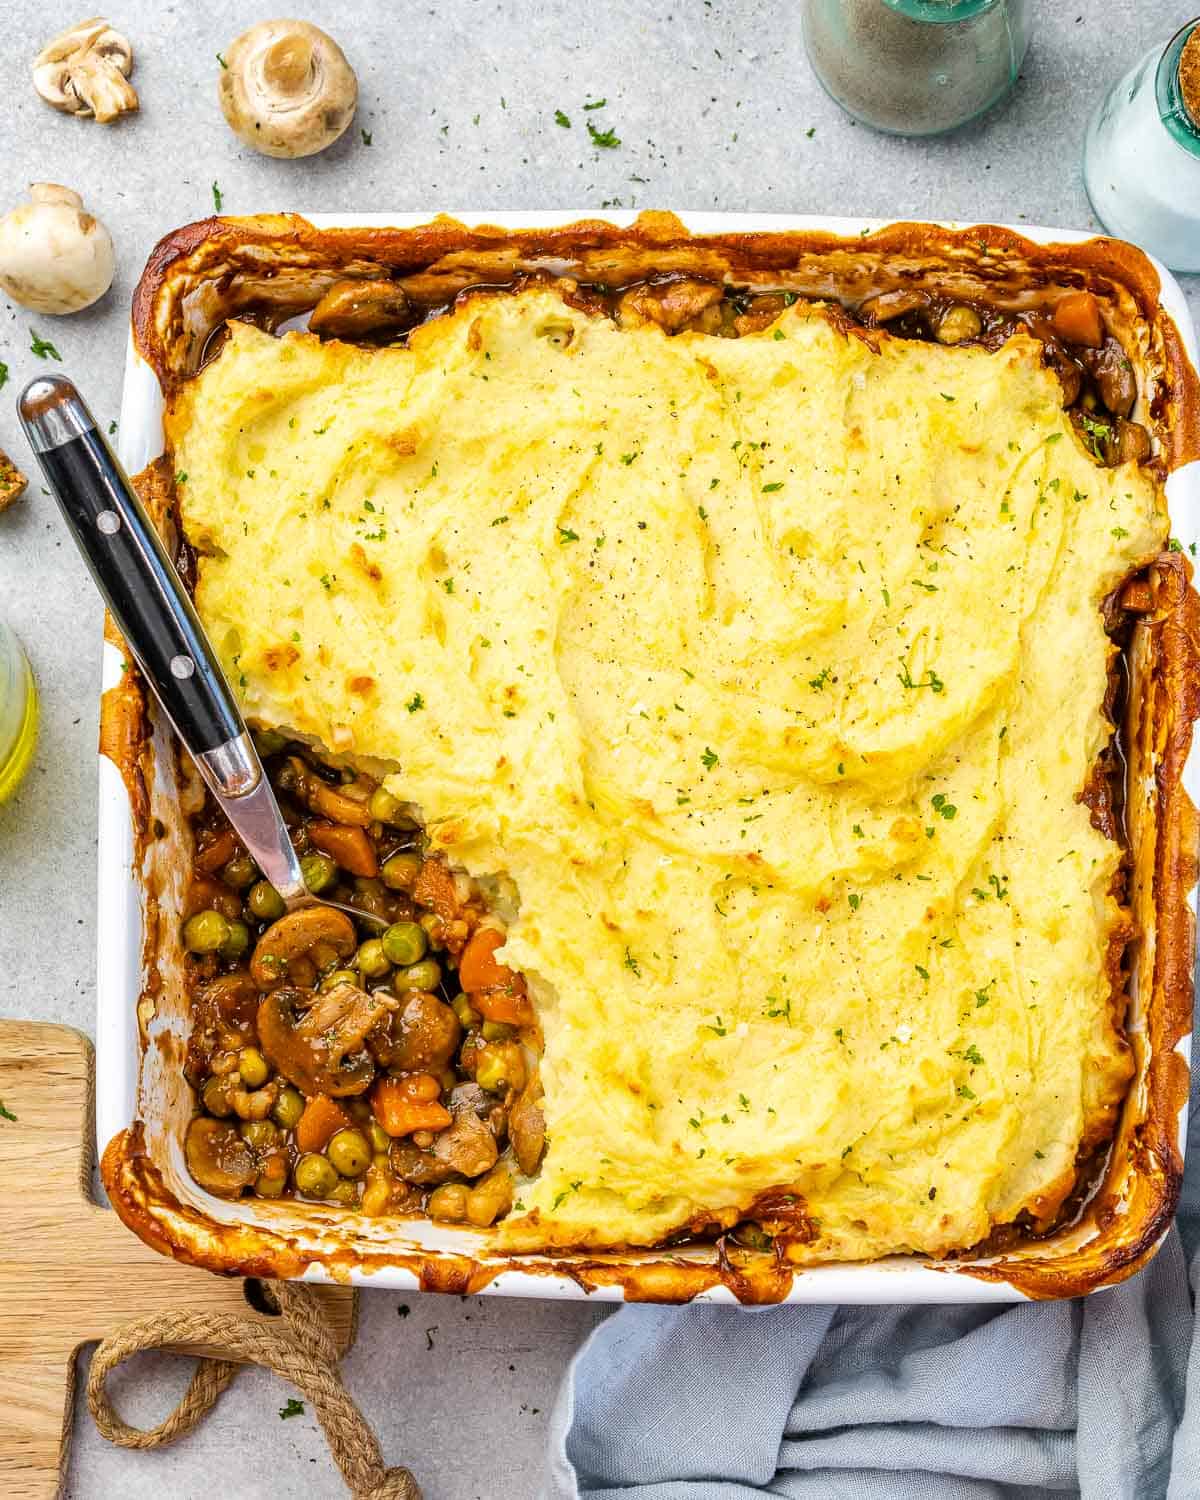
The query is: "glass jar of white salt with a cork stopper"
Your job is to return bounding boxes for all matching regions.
[1083,17,1200,272]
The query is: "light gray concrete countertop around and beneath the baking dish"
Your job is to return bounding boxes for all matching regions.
[0,0,1200,1500]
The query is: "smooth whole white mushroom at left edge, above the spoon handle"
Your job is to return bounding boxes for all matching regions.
[0,183,114,314]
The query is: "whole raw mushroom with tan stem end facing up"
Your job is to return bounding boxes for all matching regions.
[219,21,359,156]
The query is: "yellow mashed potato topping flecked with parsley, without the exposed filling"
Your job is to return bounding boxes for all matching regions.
[168,288,1166,1259]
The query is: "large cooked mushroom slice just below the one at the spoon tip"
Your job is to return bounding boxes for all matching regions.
[258,984,398,1098]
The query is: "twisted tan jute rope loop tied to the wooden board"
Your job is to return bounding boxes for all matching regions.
[87,1281,422,1500]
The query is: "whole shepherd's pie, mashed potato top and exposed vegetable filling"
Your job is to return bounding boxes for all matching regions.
[167,278,1167,1262]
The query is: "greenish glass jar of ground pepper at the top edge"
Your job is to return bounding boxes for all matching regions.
[801,0,1031,135]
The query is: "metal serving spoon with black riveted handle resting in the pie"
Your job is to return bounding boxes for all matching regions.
[17,375,387,927]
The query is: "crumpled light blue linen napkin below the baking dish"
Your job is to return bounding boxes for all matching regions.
[543,1026,1200,1500]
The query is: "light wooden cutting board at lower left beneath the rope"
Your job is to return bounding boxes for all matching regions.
[0,1022,354,1500]
